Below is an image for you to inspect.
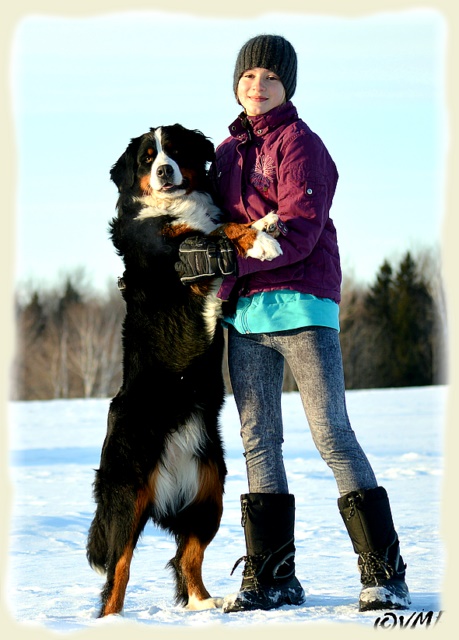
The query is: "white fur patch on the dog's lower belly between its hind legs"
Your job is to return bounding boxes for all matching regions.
[154,415,205,516]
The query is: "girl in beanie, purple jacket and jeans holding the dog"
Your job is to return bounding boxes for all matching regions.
[177,35,410,612]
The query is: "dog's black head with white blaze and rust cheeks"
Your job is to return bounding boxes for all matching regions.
[110,124,215,198]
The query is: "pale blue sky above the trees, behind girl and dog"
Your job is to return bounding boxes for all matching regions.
[11,10,448,288]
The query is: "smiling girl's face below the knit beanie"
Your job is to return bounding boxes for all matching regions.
[237,67,285,116]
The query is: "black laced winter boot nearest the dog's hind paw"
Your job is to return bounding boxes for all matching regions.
[222,493,305,613]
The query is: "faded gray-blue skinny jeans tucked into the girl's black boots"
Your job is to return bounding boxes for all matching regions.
[228,327,377,496]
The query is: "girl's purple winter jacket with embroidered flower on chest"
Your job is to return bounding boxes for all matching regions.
[210,102,341,302]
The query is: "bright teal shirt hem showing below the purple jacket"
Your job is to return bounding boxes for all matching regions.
[223,289,339,333]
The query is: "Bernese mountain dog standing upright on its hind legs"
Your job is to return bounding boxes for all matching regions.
[87,124,282,616]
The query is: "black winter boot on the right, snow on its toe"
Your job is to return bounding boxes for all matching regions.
[338,487,411,611]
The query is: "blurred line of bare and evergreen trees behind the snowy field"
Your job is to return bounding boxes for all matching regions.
[11,251,447,400]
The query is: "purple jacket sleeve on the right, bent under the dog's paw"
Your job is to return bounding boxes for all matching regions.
[238,131,338,276]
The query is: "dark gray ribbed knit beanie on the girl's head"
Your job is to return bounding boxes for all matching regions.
[233,35,297,101]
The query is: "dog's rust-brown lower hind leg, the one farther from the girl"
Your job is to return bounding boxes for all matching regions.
[99,488,150,617]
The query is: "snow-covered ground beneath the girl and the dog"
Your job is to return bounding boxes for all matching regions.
[4,387,448,638]
